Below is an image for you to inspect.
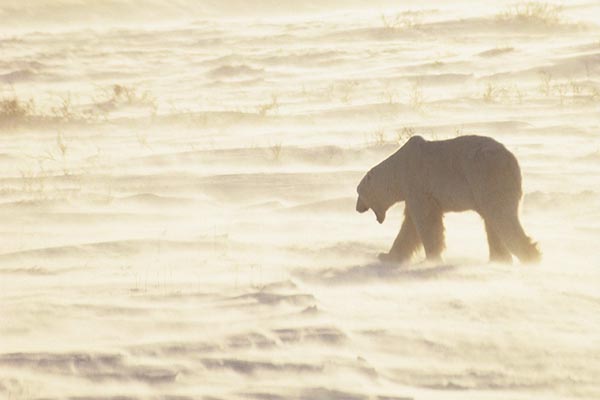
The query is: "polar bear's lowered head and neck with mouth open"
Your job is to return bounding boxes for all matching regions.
[356,136,425,224]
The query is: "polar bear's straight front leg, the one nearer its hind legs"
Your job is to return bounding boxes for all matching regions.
[406,195,445,262]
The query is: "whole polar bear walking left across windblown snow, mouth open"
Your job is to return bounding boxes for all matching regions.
[356,136,541,263]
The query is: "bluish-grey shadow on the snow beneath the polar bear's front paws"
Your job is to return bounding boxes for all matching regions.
[295,262,458,284]
